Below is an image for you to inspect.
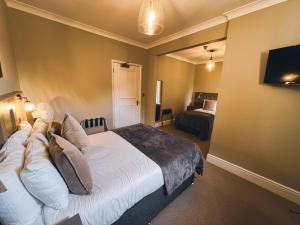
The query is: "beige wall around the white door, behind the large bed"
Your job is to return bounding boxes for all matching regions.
[10,9,147,125]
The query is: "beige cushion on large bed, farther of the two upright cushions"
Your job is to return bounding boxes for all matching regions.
[61,113,90,150]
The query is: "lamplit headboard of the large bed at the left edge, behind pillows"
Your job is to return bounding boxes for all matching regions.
[0,91,21,147]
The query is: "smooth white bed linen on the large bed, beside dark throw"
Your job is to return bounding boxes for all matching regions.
[43,131,164,225]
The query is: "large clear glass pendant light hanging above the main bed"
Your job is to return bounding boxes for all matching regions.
[138,0,165,35]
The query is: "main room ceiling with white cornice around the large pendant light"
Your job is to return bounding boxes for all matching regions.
[5,0,287,49]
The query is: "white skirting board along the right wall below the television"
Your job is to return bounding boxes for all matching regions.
[207,154,300,205]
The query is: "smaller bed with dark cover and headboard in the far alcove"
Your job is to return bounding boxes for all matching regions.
[174,92,218,140]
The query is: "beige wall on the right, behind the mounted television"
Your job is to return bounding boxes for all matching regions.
[210,0,300,190]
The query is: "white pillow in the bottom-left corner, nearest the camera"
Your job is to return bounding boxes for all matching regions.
[0,171,42,225]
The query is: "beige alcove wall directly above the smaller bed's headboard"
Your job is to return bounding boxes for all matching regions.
[194,62,223,93]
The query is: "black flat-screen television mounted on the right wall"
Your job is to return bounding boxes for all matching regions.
[264,45,300,85]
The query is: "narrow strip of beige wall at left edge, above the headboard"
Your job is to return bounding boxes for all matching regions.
[0,0,20,95]
